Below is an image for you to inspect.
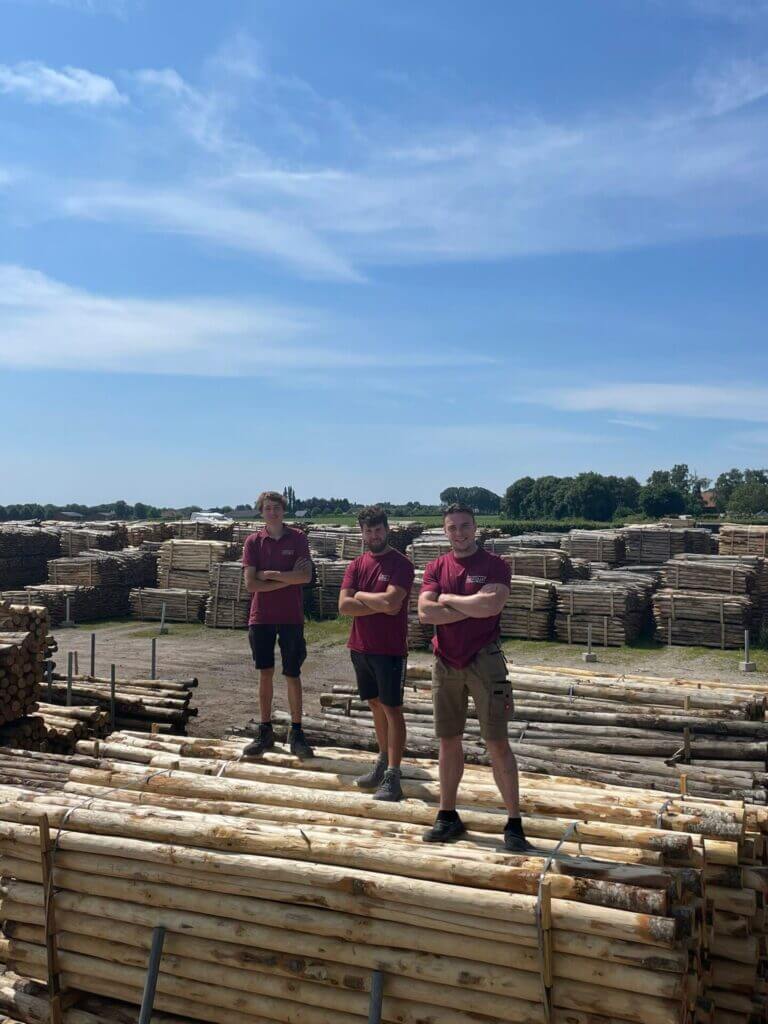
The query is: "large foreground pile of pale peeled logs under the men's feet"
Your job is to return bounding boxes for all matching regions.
[0,735,766,1024]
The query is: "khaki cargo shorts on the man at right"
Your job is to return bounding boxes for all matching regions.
[432,642,514,740]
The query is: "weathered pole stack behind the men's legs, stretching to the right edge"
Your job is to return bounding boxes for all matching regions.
[311,666,768,803]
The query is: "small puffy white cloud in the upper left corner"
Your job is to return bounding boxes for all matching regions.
[0,60,126,106]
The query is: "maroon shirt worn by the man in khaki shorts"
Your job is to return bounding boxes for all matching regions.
[421,548,512,669]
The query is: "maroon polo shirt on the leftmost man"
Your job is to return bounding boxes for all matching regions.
[243,526,309,626]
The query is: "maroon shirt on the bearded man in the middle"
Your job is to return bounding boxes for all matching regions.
[341,549,414,657]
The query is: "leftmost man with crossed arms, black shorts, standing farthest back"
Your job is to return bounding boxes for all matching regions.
[243,490,313,759]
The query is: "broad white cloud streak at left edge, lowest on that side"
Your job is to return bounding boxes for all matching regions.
[0,264,475,376]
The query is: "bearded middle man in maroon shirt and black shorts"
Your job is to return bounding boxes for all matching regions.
[339,505,414,801]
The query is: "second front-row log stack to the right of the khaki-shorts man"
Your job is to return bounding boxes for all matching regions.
[555,570,653,647]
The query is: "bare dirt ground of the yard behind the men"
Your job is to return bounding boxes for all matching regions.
[55,621,768,736]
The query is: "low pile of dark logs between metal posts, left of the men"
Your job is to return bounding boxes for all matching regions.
[44,673,198,734]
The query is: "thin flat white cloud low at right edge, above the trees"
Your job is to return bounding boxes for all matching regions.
[528,381,768,423]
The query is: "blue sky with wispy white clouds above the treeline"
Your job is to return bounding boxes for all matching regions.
[0,0,768,506]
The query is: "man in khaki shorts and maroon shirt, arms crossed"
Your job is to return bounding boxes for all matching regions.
[419,505,531,853]
